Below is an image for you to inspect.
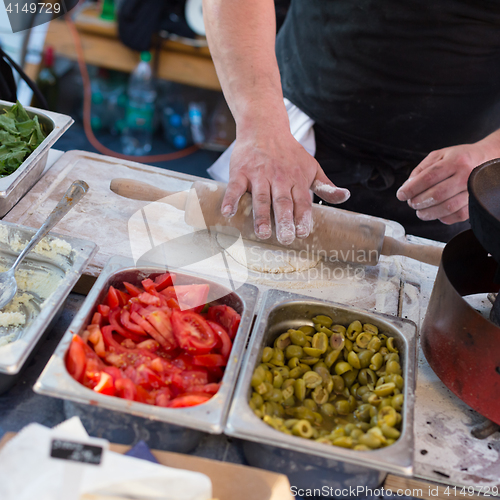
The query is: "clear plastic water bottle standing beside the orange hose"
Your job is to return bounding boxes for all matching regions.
[122,52,156,156]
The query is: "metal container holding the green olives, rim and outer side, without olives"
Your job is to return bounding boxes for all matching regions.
[225,290,416,497]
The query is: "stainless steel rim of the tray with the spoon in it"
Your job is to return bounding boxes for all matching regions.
[0,221,97,375]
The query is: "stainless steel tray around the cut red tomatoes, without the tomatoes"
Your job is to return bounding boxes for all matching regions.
[34,257,258,434]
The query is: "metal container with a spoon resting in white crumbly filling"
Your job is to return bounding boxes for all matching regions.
[0,221,97,393]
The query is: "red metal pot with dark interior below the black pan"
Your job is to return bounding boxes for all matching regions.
[421,229,500,425]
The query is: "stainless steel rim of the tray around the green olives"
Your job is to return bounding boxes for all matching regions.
[224,290,416,475]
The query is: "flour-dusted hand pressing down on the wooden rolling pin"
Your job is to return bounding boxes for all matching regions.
[222,127,350,245]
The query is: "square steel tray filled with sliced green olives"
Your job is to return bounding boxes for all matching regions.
[226,290,416,474]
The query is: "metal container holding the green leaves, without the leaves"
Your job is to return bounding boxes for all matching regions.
[0,100,73,217]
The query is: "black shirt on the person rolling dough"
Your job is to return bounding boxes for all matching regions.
[276,0,500,158]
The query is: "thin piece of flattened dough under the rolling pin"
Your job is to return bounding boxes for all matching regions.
[217,233,321,274]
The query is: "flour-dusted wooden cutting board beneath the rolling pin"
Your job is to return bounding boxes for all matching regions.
[4,151,404,314]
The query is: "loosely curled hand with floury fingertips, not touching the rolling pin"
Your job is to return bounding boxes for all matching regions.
[397,135,500,224]
